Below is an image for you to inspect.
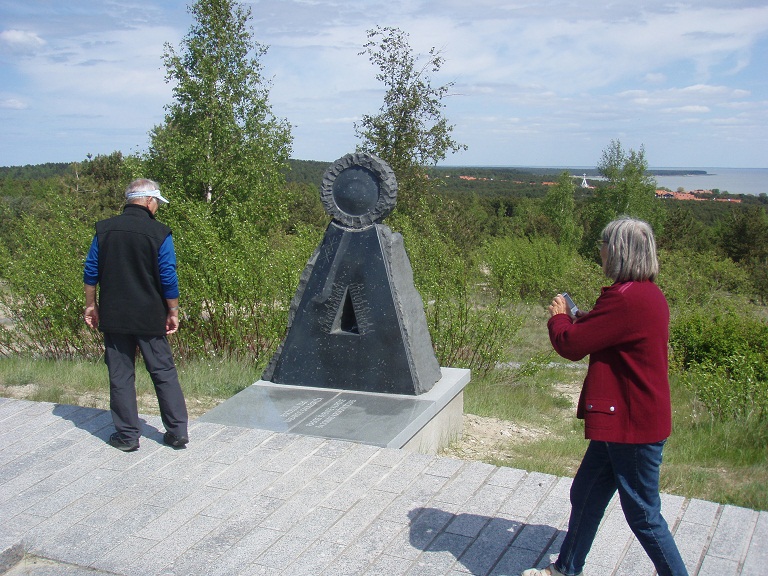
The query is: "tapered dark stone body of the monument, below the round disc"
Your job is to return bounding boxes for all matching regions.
[262,222,440,394]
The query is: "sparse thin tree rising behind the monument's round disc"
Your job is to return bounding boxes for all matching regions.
[355,26,466,210]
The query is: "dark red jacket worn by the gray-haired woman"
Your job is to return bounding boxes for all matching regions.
[547,281,672,444]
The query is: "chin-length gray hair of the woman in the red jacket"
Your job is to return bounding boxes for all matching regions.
[602,216,659,282]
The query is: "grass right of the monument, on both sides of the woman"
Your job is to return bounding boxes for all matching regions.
[464,366,768,510]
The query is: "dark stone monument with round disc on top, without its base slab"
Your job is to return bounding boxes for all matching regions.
[262,153,441,395]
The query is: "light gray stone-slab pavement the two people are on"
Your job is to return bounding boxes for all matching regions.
[0,398,768,576]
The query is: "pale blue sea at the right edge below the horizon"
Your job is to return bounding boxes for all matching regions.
[649,168,768,196]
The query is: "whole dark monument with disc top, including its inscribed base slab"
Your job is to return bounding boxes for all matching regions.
[199,153,470,453]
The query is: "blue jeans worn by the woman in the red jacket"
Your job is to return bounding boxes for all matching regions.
[555,440,688,576]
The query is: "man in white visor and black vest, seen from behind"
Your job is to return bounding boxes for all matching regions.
[83,179,189,452]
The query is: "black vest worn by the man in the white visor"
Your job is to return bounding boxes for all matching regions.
[96,204,171,336]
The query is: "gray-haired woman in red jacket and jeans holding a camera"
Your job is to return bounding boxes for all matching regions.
[523,217,687,576]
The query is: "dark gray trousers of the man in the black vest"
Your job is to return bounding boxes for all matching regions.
[104,333,188,440]
